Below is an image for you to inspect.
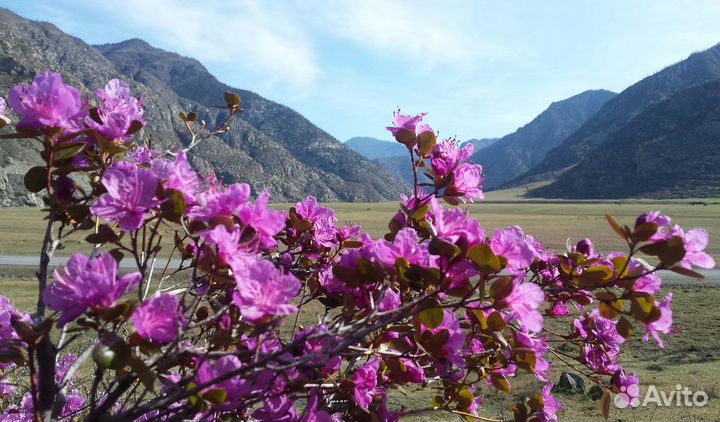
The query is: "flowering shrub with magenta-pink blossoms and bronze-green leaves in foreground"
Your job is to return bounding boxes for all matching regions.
[0,72,714,422]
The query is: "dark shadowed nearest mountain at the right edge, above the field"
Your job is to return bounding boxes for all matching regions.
[531,79,720,198]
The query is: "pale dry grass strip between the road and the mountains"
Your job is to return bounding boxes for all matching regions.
[0,189,720,260]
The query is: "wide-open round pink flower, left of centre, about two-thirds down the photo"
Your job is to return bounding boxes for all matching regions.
[233,260,300,323]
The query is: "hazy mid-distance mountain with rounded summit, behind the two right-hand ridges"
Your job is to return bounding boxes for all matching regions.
[470,90,616,189]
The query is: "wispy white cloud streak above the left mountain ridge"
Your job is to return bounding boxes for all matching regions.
[40,0,320,90]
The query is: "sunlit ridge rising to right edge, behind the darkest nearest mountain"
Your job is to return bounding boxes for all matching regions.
[510,44,720,185]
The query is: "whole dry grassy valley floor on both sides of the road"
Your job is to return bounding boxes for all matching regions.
[0,191,720,422]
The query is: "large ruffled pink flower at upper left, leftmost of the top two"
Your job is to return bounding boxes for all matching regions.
[8,72,85,130]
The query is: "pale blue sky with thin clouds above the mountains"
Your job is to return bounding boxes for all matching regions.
[3,0,720,141]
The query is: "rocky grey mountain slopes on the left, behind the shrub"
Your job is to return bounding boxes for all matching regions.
[0,9,405,206]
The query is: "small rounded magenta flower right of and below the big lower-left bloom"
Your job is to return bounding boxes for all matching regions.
[132,293,185,344]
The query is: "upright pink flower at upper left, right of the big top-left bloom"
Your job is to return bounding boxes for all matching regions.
[85,79,145,141]
